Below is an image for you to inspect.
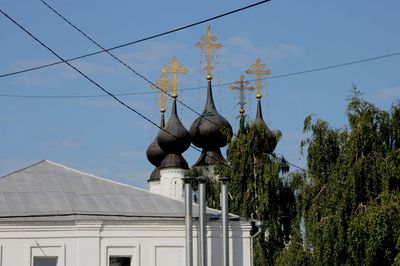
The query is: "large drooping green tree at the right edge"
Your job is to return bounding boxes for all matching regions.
[286,88,400,265]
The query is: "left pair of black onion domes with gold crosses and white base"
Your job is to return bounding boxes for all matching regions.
[147,57,190,200]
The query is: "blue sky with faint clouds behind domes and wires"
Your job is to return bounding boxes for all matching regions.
[0,0,400,188]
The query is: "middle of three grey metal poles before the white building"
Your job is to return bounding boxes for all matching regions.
[199,177,207,266]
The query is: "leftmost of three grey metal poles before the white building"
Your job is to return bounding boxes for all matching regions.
[182,177,193,266]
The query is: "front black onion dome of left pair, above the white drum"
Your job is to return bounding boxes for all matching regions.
[157,99,190,169]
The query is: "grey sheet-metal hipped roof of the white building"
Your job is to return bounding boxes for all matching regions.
[0,160,228,220]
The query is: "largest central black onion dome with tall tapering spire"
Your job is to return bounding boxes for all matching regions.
[190,79,232,150]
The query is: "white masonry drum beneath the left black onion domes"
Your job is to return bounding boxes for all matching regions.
[149,168,185,200]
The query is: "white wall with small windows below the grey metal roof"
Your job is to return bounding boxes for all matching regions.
[0,220,250,266]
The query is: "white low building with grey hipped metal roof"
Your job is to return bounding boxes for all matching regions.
[0,161,250,266]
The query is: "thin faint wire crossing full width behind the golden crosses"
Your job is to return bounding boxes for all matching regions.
[0,52,400,98]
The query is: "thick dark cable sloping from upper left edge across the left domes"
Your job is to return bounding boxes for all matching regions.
[0,9,230,167]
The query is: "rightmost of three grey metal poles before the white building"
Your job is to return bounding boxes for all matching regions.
[220,177,229,266]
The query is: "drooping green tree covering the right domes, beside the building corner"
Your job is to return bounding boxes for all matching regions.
[216,117,295,265]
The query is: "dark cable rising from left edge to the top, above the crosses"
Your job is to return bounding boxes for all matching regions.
[0,0,270,78]
